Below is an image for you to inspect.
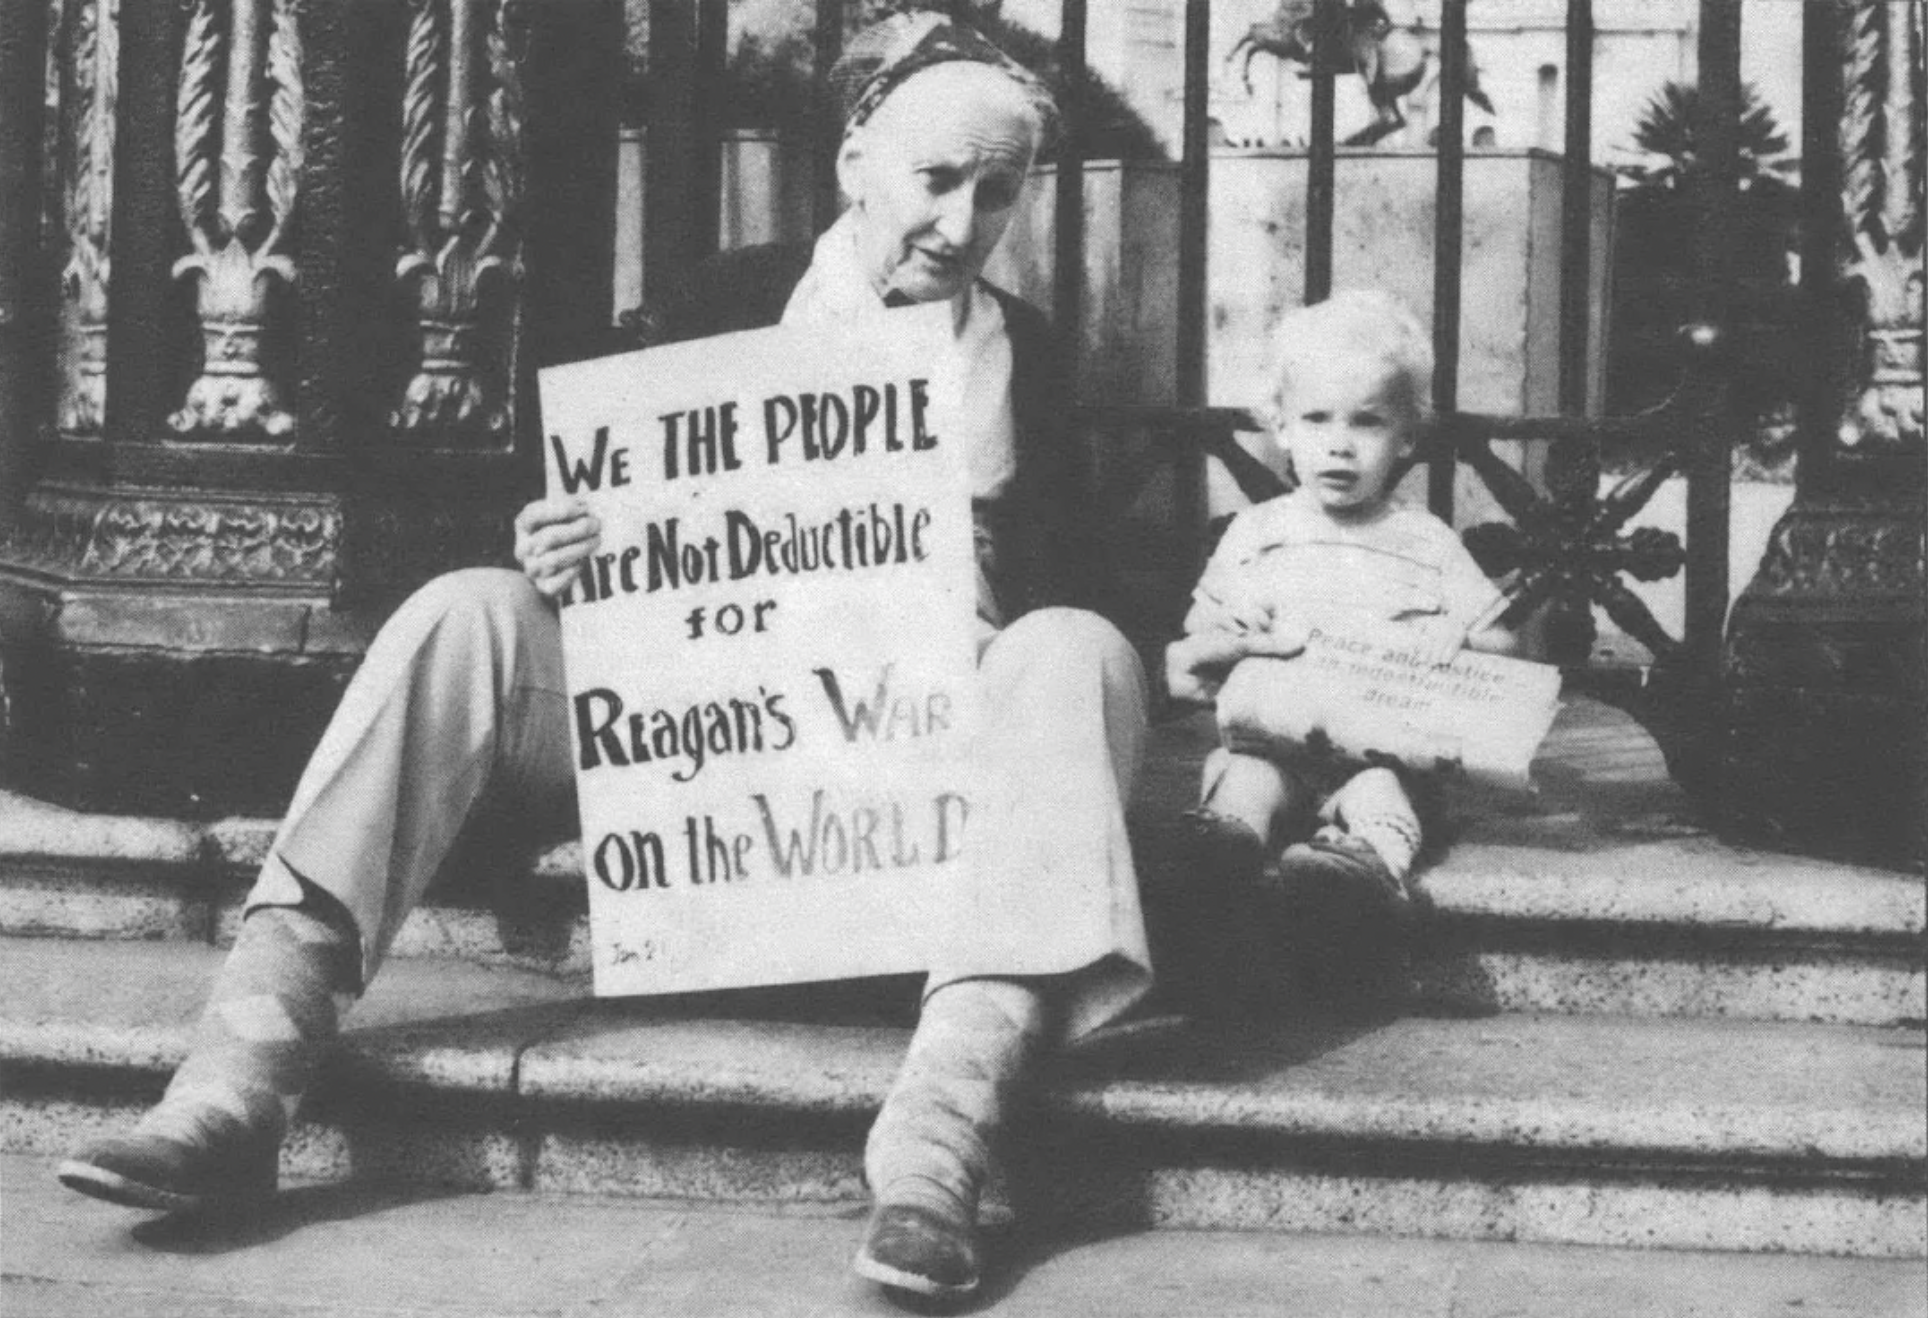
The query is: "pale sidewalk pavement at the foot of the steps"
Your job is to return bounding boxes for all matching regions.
[0,1156,1928,1318]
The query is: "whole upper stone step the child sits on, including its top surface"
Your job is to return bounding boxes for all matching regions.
[0,701,1928,1025]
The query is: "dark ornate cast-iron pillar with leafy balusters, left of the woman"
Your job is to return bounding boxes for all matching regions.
[0,0,623,815]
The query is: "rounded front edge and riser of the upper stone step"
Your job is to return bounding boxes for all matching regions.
[0,796,1928,1025]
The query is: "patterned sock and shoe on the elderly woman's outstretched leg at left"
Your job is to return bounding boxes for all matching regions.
[56,906,357,1212]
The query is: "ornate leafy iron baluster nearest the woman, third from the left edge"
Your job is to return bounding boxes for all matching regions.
[389,0,522,445]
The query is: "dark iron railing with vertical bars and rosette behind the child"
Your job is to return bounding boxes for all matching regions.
[1057,0,1739,784]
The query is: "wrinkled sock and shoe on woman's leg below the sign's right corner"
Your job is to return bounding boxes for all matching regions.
[852,979,1045,1301]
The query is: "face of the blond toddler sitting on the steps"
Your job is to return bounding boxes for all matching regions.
[1278,360,1417,514]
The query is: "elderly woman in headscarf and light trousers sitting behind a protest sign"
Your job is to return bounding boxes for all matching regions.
[60,13,1149,1297]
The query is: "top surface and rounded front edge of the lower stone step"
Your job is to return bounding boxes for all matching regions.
[0,944,1928,1179]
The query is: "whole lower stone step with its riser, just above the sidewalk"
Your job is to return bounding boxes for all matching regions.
[0,938,1928,1256]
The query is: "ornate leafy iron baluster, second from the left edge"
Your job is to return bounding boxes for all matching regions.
[168,0,307,439]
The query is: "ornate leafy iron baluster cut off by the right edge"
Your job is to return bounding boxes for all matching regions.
[1835,0,1928,451]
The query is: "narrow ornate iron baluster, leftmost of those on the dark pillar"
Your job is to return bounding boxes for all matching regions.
[52,0,120,435]
